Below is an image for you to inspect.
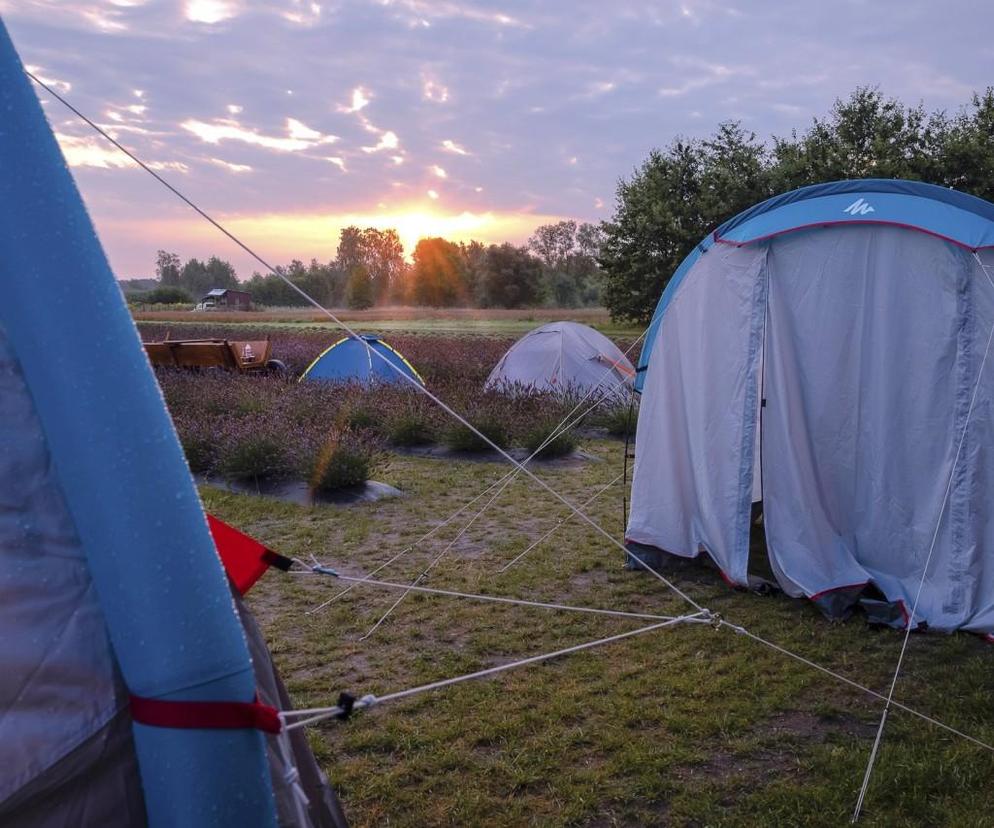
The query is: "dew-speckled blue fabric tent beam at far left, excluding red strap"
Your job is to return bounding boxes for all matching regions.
[0,22,275,827]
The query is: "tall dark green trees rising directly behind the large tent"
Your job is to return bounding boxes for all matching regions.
[598,87,994,324]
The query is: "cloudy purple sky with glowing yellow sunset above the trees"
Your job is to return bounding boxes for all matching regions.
[0,0,994,278]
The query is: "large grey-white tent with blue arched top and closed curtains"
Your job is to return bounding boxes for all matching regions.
[627,180,994,633]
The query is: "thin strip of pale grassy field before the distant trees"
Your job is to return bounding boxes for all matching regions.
[134,307,641,339]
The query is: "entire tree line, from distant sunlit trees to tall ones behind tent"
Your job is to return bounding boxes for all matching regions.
[130,87,994,316]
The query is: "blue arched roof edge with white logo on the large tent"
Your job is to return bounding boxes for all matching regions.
[635,178,994,392]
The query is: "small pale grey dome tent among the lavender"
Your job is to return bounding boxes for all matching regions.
[484,322,635,395]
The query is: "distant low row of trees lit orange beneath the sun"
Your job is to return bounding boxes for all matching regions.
[133,220,602,309]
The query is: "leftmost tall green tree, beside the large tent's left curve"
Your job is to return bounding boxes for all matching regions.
[598,123,772,324]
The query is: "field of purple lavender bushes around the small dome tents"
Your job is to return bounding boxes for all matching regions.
[139,324,631,491]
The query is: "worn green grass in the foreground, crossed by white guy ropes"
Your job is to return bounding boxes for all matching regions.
[203,440,994,826]
